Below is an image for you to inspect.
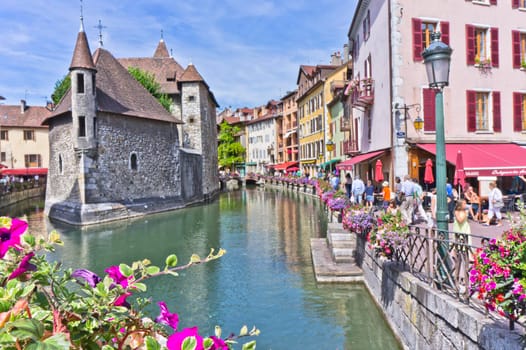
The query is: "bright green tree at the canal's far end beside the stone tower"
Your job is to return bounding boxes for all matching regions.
[217,121,245,170]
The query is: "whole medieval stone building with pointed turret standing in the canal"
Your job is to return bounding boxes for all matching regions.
[44,20,219,225]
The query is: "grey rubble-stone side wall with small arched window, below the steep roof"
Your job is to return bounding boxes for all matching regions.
[85,114,181,203]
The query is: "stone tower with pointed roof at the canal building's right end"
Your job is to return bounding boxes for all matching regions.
[179,64,219,197]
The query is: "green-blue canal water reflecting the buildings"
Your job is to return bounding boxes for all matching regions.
[6,189,400,350]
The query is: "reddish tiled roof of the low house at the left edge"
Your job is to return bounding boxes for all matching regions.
[0,105,51,128]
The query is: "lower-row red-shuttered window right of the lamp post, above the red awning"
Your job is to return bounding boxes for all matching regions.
[466,90,501,132]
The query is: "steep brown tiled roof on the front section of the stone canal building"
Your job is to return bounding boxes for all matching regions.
[46,48,183,124]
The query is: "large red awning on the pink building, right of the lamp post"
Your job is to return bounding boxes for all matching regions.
[417,143,526,177]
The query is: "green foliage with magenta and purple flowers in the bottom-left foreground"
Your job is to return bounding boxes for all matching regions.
[0,217,259,350]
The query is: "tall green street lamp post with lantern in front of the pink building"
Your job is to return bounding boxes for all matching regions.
[422,32,453,276]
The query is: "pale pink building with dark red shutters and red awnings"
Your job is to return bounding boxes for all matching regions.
[342,0,526,194]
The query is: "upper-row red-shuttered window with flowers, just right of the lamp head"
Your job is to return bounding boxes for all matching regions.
[466,24,499,68]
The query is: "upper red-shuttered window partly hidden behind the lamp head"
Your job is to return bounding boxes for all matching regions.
[412,18,449,61]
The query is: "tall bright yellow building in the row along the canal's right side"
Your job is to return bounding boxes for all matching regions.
[296,65,337,174]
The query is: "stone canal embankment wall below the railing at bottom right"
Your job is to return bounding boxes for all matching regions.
[357,237,523,350]
